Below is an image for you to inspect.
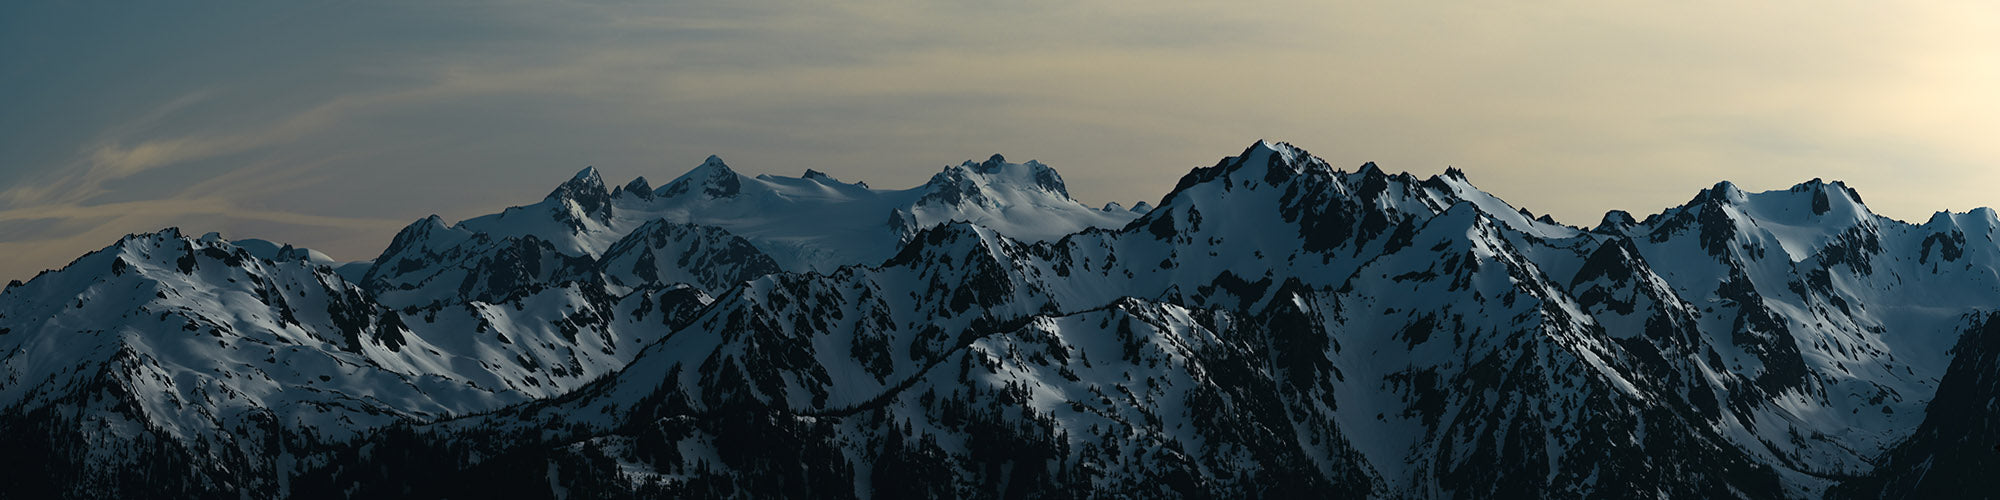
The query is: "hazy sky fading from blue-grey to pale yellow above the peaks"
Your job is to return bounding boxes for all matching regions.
[0,0,2000,280]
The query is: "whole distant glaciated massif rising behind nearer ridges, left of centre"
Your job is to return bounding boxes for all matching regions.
[368,154,1138,292]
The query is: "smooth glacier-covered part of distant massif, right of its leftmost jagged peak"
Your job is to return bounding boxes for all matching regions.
[620,154,1136,272]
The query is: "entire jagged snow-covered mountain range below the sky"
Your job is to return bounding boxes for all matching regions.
[0,142,2000,498]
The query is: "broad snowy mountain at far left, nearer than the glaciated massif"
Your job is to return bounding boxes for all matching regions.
[0,230,708,496]
